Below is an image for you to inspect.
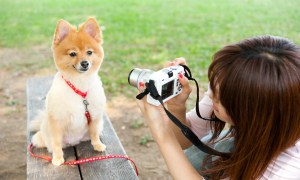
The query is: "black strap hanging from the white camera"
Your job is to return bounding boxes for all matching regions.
[136,65,230,157]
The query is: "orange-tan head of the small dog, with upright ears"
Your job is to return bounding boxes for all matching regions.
[52,18,104,75]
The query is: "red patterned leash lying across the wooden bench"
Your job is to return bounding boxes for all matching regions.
[28,143,139,176]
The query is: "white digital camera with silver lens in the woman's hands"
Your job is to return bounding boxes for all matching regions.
[128,66,184,106]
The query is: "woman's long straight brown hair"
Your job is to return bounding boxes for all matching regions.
[206,36,300,180]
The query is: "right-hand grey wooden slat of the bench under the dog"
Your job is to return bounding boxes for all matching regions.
[76,114,138,180]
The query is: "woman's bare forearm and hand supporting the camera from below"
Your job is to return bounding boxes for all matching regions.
[137,91,202,179]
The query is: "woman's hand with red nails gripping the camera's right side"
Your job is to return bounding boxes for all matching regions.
[165,57,192,109]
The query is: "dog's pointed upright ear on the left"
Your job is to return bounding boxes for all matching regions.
[53,19,71,45]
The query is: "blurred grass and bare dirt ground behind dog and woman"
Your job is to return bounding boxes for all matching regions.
[0,0,300,179]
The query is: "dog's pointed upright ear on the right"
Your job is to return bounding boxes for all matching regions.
[79,18,102,43]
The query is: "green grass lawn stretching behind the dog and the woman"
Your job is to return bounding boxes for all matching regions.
[0,0,300,95]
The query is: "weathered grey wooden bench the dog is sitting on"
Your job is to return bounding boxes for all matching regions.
[27,77,138,180]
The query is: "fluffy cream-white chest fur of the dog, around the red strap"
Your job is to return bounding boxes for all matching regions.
[46,73,106,145]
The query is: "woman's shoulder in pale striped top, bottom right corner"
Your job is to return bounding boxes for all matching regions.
[262,140,300,179]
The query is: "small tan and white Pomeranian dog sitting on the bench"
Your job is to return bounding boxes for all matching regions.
[30,18,106,166]
